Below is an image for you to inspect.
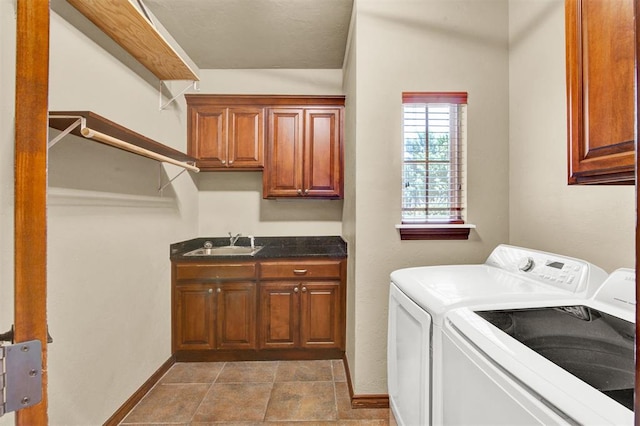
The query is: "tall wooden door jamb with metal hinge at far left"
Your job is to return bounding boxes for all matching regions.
[14,0,49,425]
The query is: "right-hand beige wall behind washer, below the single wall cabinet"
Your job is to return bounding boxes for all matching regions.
[509,0,636,271]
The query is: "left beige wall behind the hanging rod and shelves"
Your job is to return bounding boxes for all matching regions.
[48,12,198,425]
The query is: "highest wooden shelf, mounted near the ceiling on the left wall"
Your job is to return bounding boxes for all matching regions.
[67,0,199,81]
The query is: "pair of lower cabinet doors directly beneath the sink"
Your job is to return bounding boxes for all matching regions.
[174,282,256,351]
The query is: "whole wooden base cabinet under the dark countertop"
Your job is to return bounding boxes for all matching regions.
[172,258,346,361]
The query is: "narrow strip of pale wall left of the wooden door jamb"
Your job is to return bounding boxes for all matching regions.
[0,0,16,425]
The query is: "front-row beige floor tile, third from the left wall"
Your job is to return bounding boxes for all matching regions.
[265,382,337,421]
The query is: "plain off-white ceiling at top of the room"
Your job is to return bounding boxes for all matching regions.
[144,0,353,69]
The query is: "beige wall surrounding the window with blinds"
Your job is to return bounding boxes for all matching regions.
[345,0,509,394]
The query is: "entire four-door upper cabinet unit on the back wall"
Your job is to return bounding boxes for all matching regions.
[185,94,345,199]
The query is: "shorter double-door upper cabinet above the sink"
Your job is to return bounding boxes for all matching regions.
[187,98,264,171]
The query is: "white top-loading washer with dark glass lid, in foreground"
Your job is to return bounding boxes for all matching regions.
[443,269,636,426]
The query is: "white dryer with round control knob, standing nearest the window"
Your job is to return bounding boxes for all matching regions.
[387,245,607,426]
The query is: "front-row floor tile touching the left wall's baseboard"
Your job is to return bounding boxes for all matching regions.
[123,384,209,424]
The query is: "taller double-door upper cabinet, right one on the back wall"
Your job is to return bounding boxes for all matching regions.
[263,106,343,199]
